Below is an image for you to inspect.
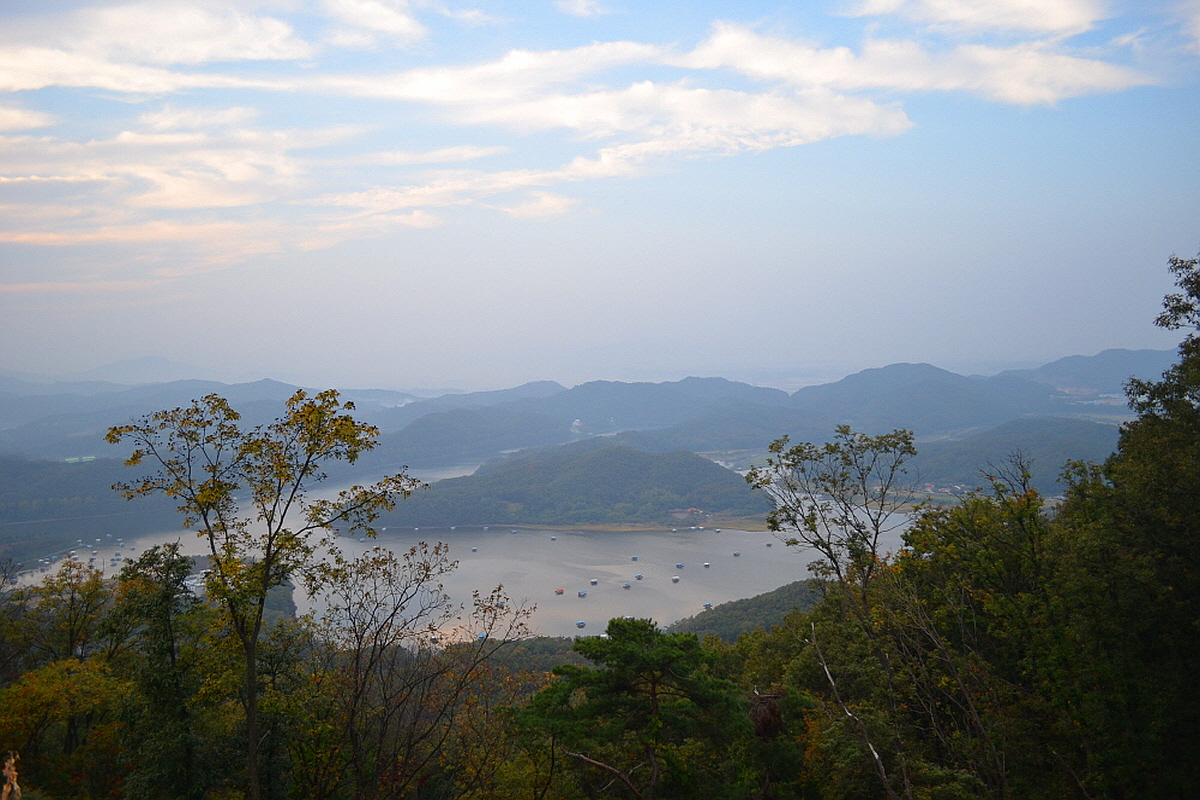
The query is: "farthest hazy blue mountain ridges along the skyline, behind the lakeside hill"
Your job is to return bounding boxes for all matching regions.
[0,350,1172,468]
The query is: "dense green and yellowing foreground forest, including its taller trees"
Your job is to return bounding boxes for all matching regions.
[0,258,1200,800]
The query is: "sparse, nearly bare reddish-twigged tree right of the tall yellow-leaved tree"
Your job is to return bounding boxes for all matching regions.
[293,542,530,800]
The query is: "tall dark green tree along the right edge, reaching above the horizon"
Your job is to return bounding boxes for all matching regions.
[1058,248,1200,798]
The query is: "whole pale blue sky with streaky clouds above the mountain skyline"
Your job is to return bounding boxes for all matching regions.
[0,0,1200,390]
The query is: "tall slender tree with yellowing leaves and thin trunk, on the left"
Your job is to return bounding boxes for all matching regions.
[107,390,420,800]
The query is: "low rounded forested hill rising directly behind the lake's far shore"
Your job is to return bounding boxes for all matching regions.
[369,443,769,527]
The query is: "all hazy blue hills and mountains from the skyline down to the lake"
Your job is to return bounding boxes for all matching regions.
[0,350,1172,554]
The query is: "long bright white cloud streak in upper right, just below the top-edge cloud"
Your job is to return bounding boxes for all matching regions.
[677,23,1151,106]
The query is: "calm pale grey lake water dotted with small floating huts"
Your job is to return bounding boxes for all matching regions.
[24,468,899,636]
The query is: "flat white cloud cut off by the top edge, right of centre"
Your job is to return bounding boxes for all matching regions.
[854,0,1108,35]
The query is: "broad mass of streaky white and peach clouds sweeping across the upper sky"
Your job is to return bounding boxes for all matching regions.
[0,0,1166,293]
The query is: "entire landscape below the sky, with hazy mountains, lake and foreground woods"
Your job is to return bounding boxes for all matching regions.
[0,326,1195,800]
